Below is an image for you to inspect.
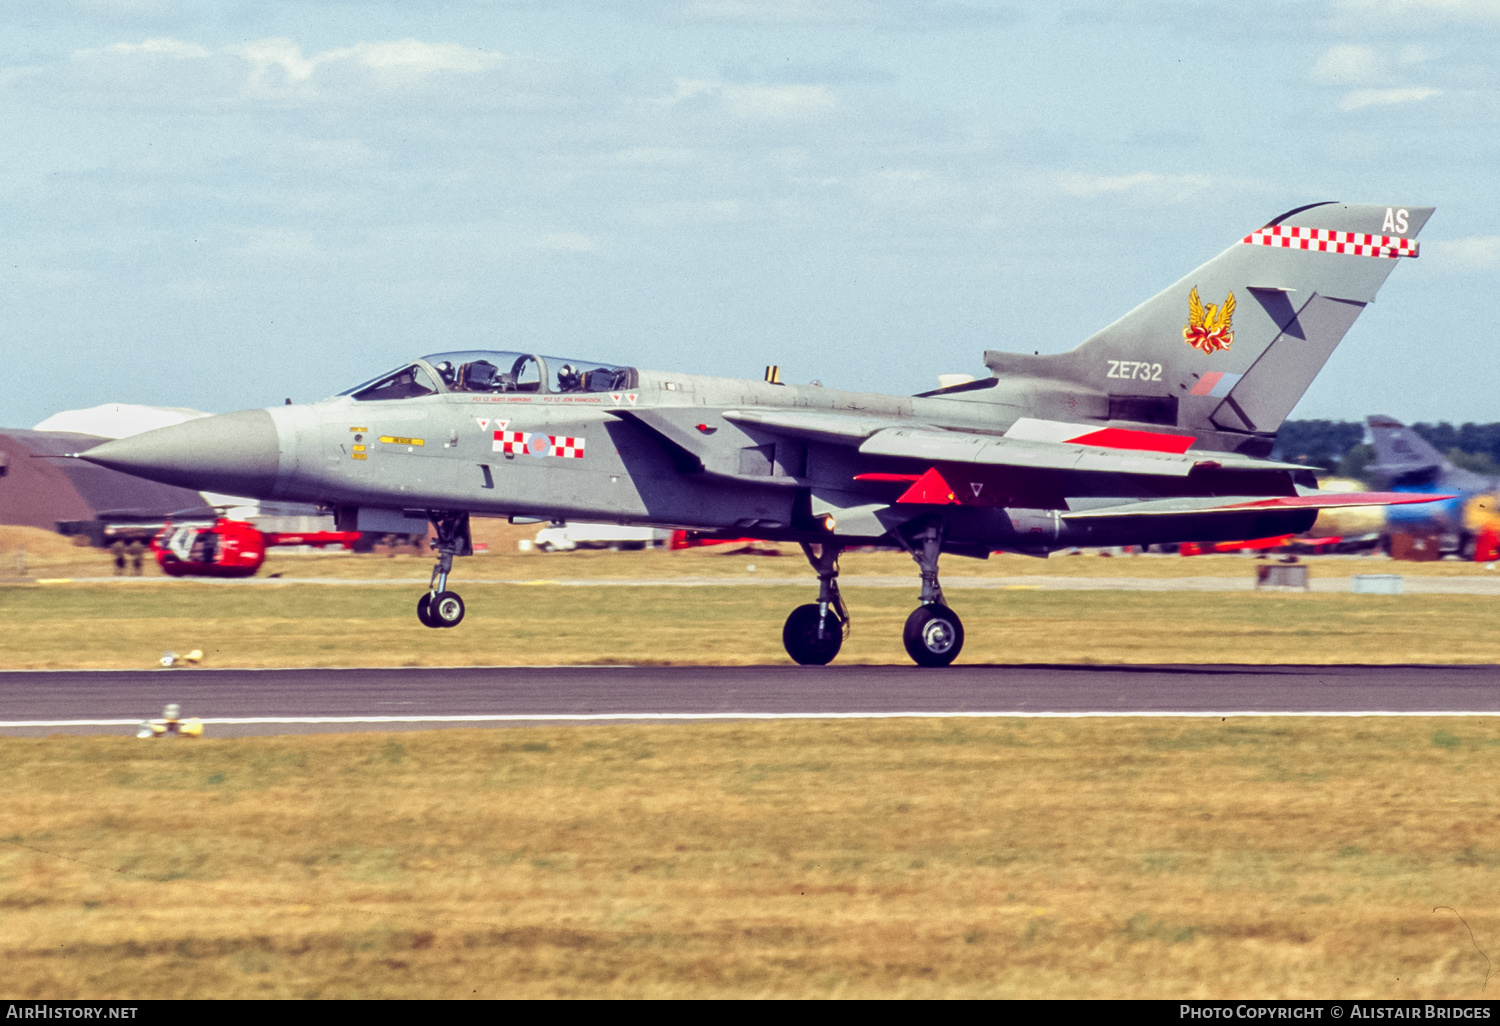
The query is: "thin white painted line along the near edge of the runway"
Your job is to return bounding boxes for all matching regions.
[0,710,1500,729]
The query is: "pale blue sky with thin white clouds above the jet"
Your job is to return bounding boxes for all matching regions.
[0,0,1500,428]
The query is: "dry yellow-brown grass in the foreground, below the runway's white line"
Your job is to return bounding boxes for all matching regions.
[0,719,1500,998]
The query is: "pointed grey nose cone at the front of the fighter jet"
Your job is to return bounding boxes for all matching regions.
[78,410,281,498]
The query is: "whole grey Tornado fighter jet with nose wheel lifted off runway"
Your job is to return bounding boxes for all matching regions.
[78,203,1436,666]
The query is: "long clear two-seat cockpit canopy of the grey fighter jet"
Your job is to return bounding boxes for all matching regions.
[339,350,639,401]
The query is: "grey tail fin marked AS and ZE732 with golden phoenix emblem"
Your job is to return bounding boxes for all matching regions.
[984,203,1433,452]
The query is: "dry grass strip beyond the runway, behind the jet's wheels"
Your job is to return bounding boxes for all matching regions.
[0,581,1500,669]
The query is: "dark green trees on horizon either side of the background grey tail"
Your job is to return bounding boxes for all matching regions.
[1274,420,1500,483]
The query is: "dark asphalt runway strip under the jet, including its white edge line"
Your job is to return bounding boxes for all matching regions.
[0,665,1500,737]
